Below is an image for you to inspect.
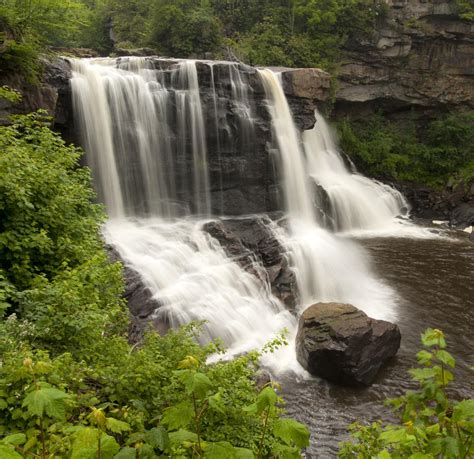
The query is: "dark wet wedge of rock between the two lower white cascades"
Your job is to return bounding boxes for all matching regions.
[203,216,297,310]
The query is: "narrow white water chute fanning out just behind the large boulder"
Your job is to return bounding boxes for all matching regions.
[260,69,395,319]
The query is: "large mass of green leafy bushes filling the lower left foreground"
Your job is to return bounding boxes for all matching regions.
[0,110,309,459]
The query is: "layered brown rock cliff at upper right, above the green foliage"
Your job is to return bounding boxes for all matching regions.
[335,0,474,118]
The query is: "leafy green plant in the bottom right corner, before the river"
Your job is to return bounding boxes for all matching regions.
[339,329,474,459]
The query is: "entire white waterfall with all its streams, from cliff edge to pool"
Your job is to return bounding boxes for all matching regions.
[71,58,406,370]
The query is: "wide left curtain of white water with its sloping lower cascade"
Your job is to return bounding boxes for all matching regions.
[72,59,295,366]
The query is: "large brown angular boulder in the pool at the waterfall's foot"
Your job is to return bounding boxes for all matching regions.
[296,303,401,386]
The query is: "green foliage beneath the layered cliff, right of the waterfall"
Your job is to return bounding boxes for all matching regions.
[338,112,474,187]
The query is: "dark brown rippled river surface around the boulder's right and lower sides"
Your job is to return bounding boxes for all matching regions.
[281,232,474,459]
